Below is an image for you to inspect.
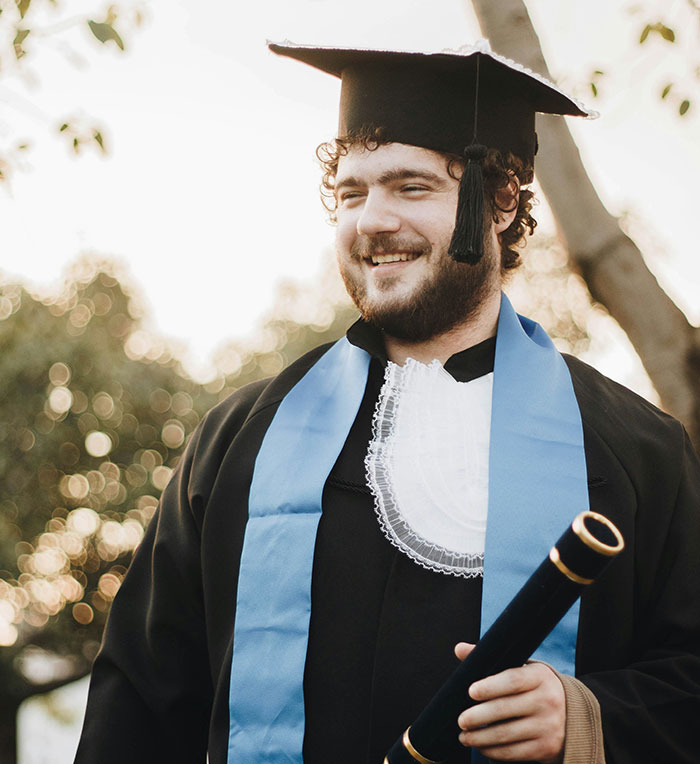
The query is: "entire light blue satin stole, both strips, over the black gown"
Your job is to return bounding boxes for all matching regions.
[228,295,588,764]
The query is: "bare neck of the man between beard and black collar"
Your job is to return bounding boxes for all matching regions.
[384,291,501,366]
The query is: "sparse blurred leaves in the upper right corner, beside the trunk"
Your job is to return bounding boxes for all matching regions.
[589,0,700,117]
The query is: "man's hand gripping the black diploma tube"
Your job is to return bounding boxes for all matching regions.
[455,642,566,764]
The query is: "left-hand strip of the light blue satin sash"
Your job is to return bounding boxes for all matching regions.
[228,339,369,764]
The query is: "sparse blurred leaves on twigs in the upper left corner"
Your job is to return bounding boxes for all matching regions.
[0,0,144,182]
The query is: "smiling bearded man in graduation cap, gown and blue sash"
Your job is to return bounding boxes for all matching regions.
[76,41,700,764]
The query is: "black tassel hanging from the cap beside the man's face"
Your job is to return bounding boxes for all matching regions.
[448,143,487,265]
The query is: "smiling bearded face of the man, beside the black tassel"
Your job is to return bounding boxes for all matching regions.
[335,143,500,342]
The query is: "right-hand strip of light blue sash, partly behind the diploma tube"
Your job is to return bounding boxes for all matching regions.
[481,295,588,675]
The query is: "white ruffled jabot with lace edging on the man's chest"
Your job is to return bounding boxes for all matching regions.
[365,358,493,578]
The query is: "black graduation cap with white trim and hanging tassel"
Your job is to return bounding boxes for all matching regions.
[268,40,597,263]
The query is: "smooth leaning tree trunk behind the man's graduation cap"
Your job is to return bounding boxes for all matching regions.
[472,0,700,450]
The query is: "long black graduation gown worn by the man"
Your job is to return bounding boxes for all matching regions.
[76,324,700,764]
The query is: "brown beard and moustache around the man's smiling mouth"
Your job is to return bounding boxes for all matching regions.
[340,234,497,343]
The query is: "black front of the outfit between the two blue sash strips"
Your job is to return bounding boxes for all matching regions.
[304,320,496,764]
